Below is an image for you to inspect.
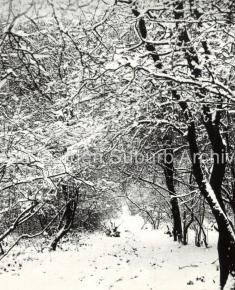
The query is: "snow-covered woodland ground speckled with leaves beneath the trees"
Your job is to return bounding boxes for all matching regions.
[0,215,235,290]
